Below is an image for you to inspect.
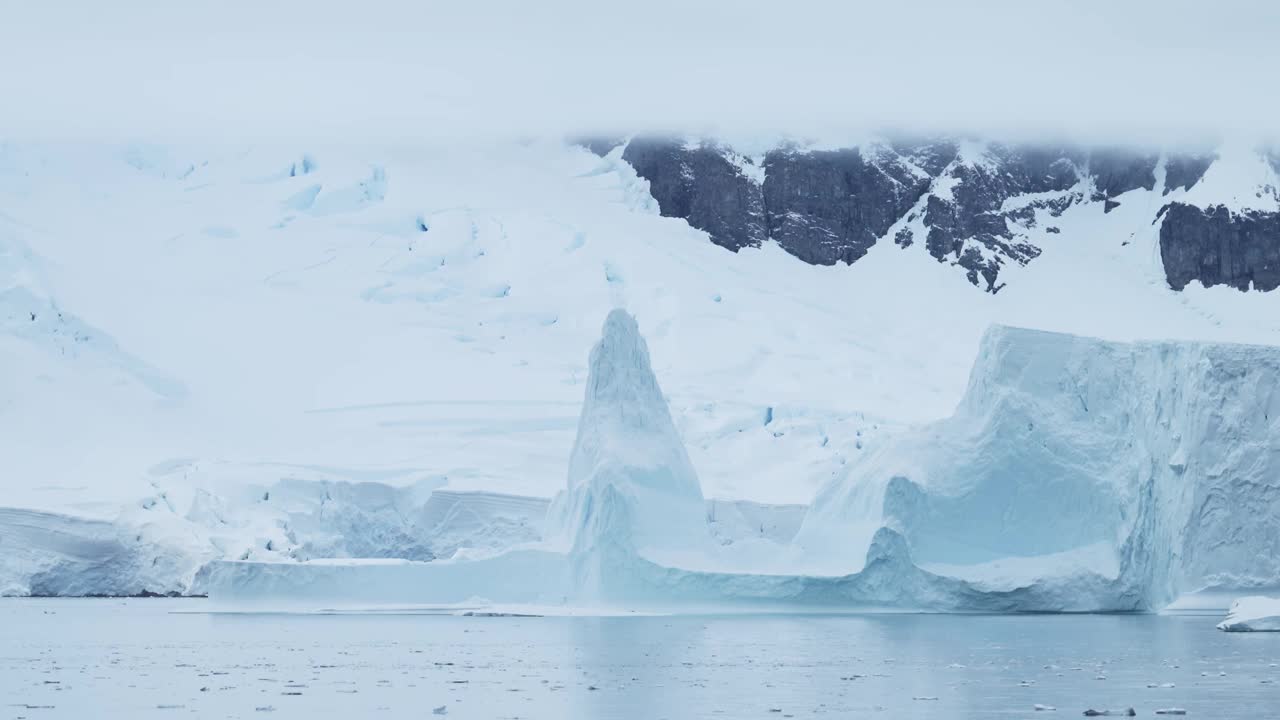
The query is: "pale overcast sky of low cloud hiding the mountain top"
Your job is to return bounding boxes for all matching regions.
[0,0,1280,141]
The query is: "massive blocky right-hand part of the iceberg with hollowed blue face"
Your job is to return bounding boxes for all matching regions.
[799,327,1280,610]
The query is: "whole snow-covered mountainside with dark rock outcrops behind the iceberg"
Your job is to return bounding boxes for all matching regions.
[0,137,1280,592]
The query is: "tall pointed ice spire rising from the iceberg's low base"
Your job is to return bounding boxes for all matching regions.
[549,304,708,563]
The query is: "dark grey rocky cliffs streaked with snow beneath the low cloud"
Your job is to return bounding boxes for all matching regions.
[601,137,1280,292]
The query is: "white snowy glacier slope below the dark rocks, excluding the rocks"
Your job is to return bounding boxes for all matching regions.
[0,141,1280,597]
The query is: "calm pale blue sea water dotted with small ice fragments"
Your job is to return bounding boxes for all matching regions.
[0,600,1280,720]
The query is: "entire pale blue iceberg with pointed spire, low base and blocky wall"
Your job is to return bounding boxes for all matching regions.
[193,310,1280,612]
